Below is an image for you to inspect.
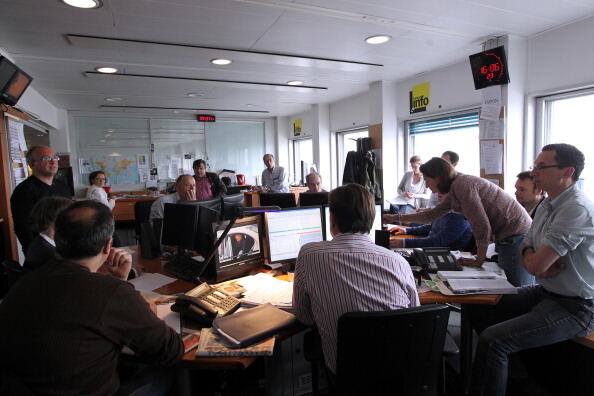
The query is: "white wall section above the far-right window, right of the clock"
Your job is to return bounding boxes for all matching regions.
[526,17,594,94]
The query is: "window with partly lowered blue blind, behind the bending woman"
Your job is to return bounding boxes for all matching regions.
[406,111,480,176]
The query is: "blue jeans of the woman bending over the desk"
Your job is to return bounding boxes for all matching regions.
[495,234,535,287]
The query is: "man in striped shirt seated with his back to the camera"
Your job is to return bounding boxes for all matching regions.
[293,184,419,373]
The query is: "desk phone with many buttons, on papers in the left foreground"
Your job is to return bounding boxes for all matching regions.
[171,282,240,326]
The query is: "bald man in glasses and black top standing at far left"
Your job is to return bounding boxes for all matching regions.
[10,146,71,252]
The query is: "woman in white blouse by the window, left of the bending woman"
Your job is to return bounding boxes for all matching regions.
[390,155,431,214]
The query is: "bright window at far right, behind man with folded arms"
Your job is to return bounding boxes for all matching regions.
[536,90,594,198]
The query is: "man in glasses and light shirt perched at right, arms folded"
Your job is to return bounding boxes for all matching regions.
[471,144,594,396]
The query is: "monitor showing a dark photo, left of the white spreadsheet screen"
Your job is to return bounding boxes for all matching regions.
[206,216,262,282]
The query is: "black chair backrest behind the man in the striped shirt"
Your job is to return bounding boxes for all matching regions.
[336,305,449,395]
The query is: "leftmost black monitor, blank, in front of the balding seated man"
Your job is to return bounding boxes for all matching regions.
[161,203,199,250]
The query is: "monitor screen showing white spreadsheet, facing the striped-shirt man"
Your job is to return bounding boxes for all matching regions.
[265,208,324,263]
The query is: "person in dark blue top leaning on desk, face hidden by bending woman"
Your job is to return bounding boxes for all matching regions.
[390,193,472,250]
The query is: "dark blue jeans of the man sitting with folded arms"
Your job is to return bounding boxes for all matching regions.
[469,286,594,396]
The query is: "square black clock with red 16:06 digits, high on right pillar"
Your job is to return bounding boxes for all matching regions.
[469,46,509,89]
